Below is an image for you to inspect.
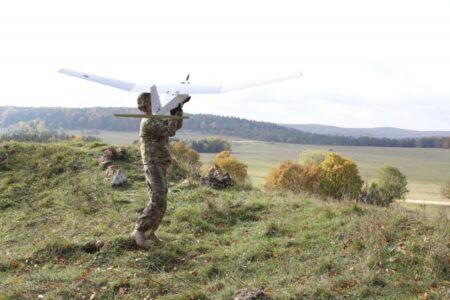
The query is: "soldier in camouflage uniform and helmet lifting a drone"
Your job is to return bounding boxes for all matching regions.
[131,93,189,249]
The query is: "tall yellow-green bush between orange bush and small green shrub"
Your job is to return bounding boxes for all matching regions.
[318,152,363,200]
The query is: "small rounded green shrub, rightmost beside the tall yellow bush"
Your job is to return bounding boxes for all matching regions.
[378,166,408,202]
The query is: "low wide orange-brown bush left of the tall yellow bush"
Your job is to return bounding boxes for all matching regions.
[265,161,320,193]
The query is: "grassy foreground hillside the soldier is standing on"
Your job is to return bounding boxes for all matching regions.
[0,142,450,299]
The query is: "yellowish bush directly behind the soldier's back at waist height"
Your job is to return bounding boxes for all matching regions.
[168,141,201,182]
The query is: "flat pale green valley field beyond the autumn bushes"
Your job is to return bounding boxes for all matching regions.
[80,131,450,200]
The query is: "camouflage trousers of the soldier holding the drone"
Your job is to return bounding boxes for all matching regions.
[135,162,168,231]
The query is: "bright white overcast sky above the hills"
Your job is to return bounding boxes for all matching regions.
[0,0,450,130]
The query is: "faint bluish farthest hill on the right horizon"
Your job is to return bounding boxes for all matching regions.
[280,124,450,139]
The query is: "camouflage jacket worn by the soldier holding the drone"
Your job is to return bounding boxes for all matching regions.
[139,111,183,165]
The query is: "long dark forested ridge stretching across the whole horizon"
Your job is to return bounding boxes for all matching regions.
[0,107,450,148]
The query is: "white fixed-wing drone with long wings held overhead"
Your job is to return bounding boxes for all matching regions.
[59,69,302,119]
